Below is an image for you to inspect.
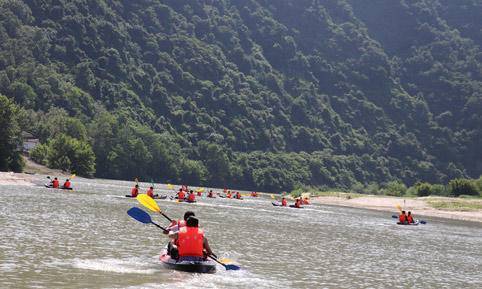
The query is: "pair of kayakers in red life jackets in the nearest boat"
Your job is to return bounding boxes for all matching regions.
[164,211,213,261]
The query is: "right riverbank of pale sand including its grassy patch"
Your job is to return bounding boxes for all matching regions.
[311,193,482,223]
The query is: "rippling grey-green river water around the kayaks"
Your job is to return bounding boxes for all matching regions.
[0,176,482,288]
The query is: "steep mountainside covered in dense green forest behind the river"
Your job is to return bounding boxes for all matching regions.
[0,0,482,190]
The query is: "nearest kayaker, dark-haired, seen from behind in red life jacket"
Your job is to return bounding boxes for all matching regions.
[169,217,213,261]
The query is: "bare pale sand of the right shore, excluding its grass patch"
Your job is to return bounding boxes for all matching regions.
[311,195,482,222]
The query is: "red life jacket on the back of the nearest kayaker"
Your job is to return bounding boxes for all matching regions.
[177,227,204,257]
